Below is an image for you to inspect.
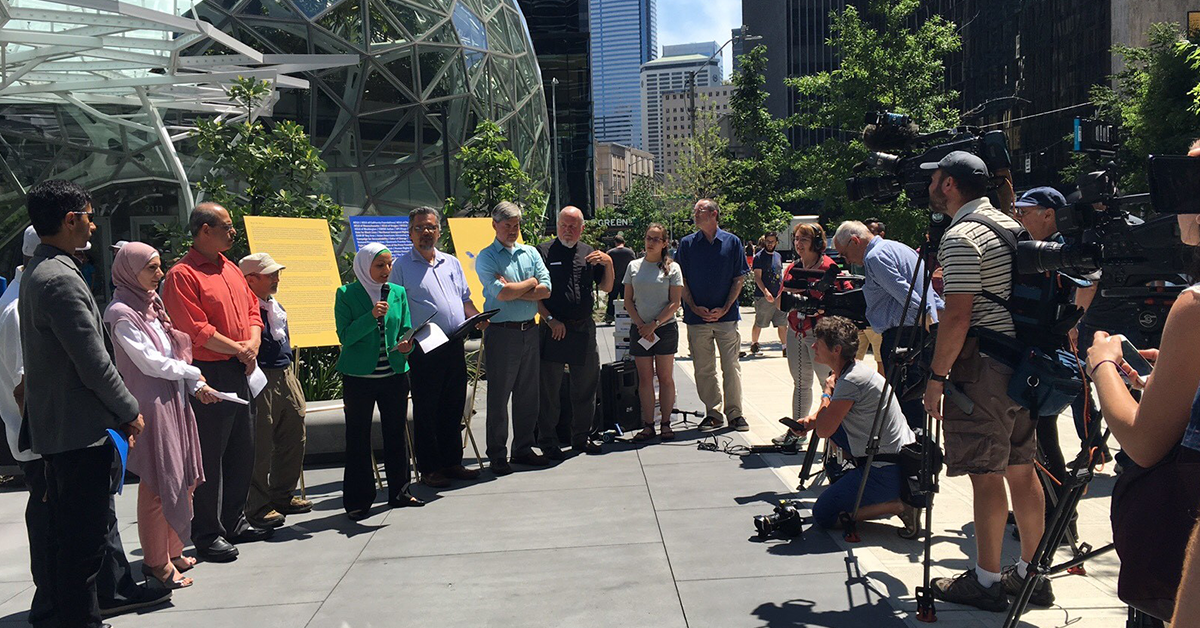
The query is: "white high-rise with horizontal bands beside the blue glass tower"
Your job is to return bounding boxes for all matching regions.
[642,42,721,163]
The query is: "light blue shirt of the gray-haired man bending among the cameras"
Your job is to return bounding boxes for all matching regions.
[863,237,946,334]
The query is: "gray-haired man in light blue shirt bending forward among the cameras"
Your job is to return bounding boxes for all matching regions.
[833,220,944,429]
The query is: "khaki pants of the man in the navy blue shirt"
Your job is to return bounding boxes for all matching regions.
[688,321,742,419]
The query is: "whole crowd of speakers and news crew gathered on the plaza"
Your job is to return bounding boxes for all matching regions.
[9,152,1200,627]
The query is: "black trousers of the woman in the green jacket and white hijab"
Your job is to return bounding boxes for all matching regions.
[342,373,412,513]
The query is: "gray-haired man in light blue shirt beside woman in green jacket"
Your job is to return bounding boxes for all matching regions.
[389,207,487,489]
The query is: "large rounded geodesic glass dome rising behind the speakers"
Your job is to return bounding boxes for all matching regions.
[187,0,550,214]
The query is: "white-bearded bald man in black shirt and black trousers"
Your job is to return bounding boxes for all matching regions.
[538,207,614,460]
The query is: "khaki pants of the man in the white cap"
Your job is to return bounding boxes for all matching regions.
[246,369,305,519]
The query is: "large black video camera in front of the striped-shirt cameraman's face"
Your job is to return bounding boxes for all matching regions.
[846,112,1012,207]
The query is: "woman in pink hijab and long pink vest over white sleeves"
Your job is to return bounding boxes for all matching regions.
[104,243,218,588]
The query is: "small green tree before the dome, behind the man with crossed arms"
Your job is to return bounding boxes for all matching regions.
[446,120,550,244]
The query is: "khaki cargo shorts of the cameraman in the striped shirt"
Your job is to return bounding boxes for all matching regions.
[942,337,1037,477]
